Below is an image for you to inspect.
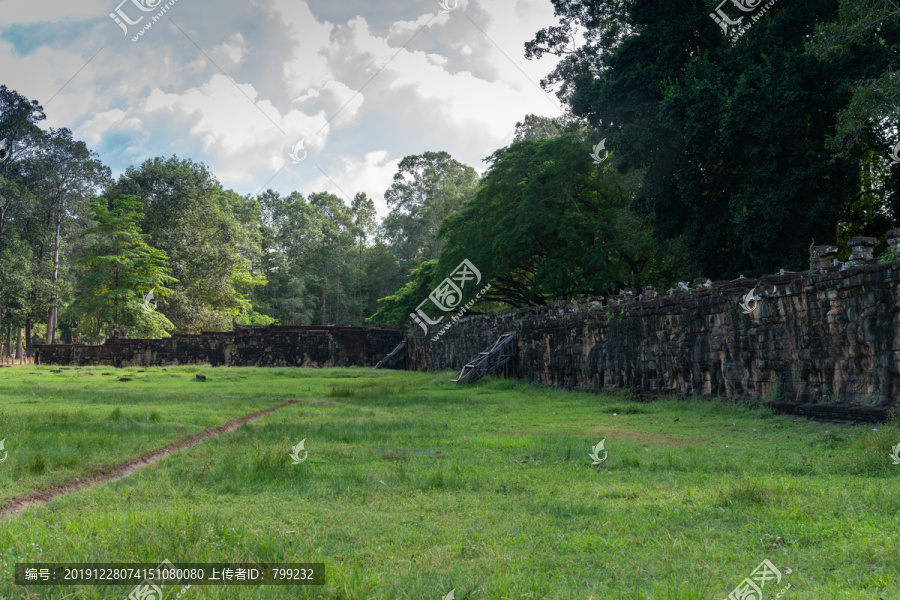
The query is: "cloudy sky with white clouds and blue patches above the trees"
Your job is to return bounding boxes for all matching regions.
[0,0,562,216]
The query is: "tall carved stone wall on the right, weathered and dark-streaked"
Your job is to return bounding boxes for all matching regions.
[408,253,900,412]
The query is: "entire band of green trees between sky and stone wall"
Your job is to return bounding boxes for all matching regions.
[0,0,900,347]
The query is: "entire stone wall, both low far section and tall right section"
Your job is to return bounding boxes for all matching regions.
[36,230,900,418]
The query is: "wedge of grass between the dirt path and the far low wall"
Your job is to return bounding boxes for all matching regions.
[0,365,338,504]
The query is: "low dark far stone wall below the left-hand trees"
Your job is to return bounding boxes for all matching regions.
[35,327,405,367]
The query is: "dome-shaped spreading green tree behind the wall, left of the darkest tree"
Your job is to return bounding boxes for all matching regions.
[370,131,685,324]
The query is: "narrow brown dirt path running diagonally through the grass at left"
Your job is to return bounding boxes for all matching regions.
[0,400,298,517]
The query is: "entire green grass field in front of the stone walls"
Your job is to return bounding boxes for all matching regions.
[0,366,900,600]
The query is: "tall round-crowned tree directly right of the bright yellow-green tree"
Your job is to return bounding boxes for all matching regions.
[109,156,266,333]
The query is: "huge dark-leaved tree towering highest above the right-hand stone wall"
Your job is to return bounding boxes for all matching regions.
[526,0,893,278]
